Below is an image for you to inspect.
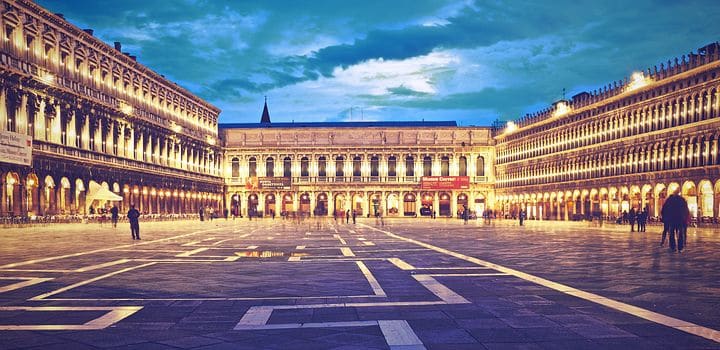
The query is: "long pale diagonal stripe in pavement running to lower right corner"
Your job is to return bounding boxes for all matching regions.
[360,224,720,343]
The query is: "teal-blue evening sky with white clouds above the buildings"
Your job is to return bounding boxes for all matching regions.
[38,0,720,125]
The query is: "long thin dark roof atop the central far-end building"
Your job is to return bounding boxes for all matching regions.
[218,121,457,129]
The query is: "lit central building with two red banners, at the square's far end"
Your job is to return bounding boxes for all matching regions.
[220,116,494,217]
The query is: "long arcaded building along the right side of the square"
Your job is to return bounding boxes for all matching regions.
[495,43,720,220]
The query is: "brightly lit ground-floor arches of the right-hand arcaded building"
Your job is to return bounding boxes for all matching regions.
[496,179,720,220]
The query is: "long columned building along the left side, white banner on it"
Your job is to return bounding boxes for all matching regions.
[0,0,223,216]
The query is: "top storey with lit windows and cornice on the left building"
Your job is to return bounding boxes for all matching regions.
[0,3,219,135]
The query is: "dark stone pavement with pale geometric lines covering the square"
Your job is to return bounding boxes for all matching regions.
[0,218,720,349]
